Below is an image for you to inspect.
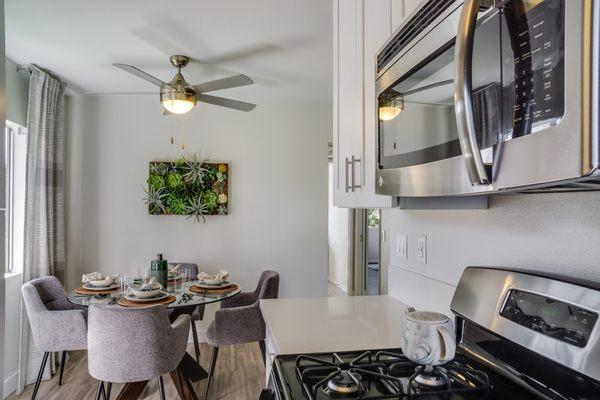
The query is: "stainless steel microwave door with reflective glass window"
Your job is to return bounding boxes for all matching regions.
[376,2,502,197]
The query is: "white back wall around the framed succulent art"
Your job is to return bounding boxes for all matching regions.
[67,95,331,297]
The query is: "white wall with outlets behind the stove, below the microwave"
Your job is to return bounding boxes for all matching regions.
[382,193,600,313]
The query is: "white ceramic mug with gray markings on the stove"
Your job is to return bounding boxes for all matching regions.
[402,308,456,365]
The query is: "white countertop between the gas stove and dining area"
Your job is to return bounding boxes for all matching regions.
[260,296,407,354]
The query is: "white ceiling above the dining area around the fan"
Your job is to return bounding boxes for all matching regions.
[5,0,332,104]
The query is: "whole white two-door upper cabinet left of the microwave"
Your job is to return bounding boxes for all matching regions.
[333,0,396,208]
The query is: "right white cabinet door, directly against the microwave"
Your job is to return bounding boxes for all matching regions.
[359,0,395,208]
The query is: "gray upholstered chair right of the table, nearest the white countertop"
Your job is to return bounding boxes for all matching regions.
[204,271,279,400]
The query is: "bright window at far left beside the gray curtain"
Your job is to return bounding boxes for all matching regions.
[4,121,27,273]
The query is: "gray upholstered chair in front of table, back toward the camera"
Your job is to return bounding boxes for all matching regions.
[88,304,190,400]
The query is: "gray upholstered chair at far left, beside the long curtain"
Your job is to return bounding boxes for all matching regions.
[21,276,87,400]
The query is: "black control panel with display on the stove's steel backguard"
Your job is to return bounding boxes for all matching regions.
[500,289,598,347]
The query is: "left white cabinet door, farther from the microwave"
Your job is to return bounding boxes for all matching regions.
[333,0,363,207]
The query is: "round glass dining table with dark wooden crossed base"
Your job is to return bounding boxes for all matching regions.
[67,284,242,400]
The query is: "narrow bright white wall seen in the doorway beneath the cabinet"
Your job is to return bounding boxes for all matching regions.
[328,163,350,292]
